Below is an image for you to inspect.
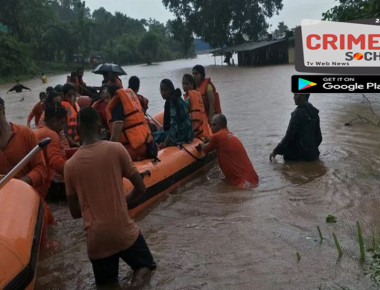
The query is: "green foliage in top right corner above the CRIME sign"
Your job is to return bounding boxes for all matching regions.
[322,0,380,21]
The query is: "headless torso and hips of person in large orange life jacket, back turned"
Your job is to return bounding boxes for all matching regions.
[106,89,153,161]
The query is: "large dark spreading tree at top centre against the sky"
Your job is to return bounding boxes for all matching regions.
[162,0,282,47]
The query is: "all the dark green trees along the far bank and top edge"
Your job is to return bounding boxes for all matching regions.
[0,0,380,78]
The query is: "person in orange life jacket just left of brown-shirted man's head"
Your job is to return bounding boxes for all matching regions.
[61,83,80,147]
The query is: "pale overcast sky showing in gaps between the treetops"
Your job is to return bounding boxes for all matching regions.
[86,0,339,30]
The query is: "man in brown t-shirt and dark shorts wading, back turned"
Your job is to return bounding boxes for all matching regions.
[64,107,156,286]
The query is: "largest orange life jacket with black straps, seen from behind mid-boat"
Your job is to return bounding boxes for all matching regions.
[106,89,153,150]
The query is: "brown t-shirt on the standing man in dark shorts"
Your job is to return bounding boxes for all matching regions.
[65,141,139,259]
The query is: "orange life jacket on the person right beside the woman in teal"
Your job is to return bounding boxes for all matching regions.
[185,90,212,137]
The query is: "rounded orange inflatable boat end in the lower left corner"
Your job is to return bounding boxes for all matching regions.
[0,179,44,289]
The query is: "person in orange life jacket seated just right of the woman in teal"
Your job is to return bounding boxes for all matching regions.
[182,74,212,138]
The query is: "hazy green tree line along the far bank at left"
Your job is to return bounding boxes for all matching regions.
[0,0,194,79]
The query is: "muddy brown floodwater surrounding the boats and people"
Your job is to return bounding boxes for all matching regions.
[0,56,380,290]
